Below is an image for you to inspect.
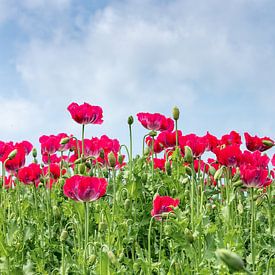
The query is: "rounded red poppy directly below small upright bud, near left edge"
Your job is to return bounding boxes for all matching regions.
[18,163,42,185]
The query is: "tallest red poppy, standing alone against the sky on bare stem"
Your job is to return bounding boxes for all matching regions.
[67,102,103,124]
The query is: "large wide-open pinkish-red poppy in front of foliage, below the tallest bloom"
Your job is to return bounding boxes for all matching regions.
[63,175,108,201]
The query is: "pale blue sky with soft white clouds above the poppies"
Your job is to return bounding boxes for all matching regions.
[0,0,275,154]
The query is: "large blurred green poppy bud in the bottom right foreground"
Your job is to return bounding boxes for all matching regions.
[216,249,244,272]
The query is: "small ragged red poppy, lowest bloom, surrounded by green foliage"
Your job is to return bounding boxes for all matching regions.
[151,195,180,220]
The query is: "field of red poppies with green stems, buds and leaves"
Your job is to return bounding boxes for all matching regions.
[0,103,275,275]
